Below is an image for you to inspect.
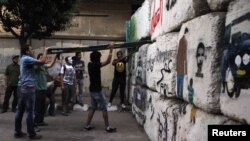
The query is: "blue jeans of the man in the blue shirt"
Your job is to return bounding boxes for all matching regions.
[15,88,36,136]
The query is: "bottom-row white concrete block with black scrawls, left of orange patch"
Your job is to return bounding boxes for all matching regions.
[144,92,181,141]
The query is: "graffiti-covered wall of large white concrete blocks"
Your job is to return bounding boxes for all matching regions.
[129,0,250,141]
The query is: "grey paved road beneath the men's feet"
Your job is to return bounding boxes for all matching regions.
[0,99,150,141]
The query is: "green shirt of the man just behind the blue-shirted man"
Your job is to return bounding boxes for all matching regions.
[35,64,48,90]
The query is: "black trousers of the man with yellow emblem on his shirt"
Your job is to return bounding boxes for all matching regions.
[109,77,126,104]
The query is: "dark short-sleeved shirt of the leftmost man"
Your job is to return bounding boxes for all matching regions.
[5,63,20,86]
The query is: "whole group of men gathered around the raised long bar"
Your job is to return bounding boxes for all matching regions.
[1,43,128,139]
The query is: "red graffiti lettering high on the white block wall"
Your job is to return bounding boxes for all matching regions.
[150,0,163,34]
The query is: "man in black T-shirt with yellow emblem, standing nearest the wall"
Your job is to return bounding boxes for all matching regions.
[108,51,128,109]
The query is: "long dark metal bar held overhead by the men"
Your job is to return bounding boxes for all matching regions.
[48,40,154,54]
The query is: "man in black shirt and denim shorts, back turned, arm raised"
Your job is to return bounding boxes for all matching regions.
[84,44,116,133]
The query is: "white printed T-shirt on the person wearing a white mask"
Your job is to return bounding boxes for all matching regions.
[60,64,75,85]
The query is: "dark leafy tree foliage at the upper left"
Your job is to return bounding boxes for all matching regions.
[0,0,77,46]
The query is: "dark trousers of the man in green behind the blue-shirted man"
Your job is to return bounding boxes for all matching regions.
[35,90,46,124]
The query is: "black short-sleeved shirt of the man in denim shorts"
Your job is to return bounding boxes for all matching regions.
[88,62,102,92]
